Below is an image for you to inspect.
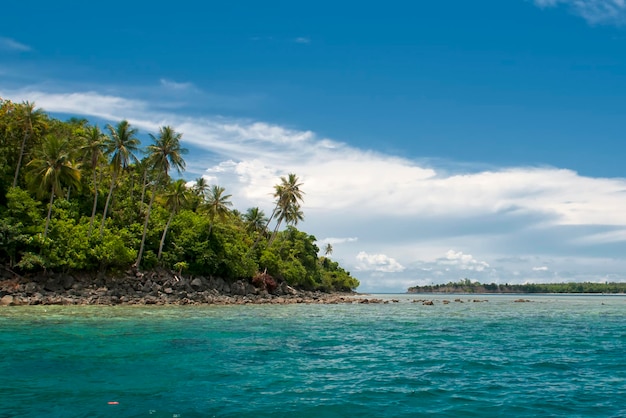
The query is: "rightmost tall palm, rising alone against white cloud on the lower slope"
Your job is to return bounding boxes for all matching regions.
[268,173,304,246]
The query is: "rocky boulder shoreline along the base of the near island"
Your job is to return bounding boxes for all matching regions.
[0,270,364,306]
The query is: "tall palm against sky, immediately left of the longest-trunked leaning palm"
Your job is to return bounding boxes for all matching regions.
[100,120,139,235]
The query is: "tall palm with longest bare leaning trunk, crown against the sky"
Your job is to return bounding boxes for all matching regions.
[135,126,187,267]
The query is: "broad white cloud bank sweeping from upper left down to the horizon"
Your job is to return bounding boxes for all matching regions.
[0,88,626,291]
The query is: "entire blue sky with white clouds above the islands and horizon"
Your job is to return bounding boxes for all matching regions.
[0,0,626,291]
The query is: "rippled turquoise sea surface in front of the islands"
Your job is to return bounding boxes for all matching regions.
[0,295,626,418]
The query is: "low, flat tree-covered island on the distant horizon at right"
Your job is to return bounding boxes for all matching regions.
[407,279,626,294]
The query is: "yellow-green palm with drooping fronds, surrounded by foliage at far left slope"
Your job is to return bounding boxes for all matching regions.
[27,135,80,238]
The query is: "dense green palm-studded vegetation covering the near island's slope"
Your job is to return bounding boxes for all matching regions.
[0,99,359,291]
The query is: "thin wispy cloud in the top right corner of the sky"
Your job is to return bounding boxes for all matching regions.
[535,0,626,25]
